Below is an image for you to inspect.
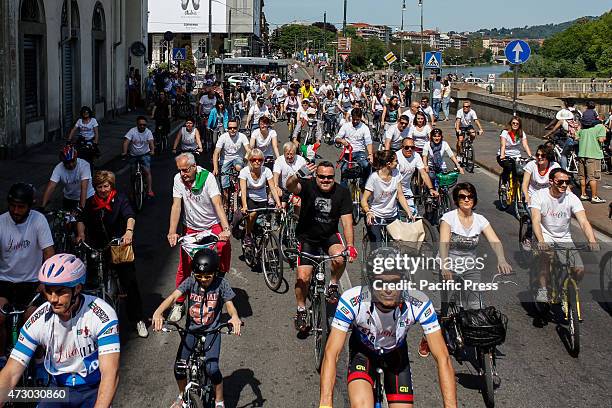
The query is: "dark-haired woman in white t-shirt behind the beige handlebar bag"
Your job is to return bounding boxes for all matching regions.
[361,150,413,242]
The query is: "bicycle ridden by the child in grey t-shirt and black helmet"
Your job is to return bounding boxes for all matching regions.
[162,321,244,408]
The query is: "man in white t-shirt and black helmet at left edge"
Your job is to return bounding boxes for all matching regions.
[0,183,55,368]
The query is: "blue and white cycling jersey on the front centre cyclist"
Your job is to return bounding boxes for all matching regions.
[332,286,440,353]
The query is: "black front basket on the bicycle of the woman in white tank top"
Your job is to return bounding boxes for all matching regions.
[457,306,508,347]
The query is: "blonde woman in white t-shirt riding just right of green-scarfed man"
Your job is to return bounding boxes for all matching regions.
[238,148,281,245]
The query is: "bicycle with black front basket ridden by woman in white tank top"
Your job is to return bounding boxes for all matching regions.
[440,274,517,408]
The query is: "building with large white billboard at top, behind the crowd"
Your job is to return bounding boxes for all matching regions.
[148,0,267,68]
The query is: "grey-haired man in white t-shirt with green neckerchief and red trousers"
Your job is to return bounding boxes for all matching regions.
[168,153,235,321]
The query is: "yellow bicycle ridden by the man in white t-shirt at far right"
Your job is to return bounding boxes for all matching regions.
[534,244,589,357]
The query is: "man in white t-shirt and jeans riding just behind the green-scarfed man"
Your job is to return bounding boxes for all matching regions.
[213,119,251,193]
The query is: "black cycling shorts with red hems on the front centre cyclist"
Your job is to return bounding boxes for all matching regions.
[347,331,414,404]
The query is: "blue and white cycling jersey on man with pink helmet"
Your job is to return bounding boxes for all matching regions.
[11,295,120,386]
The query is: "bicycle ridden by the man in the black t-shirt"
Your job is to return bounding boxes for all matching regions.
[287,248,348,372]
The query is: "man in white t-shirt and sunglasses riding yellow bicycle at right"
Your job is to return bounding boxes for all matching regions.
[529,168,598,303]
